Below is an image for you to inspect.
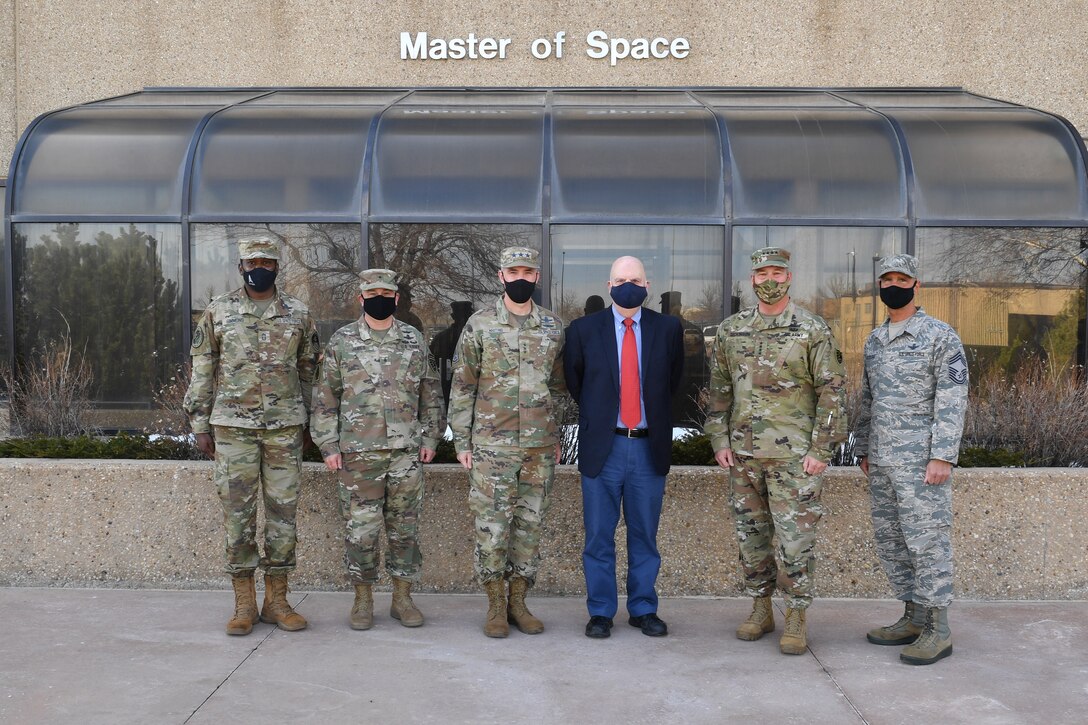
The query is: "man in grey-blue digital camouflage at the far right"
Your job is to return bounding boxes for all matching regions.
[854,255,967,665]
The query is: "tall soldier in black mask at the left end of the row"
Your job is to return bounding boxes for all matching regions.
[184,237,320,635]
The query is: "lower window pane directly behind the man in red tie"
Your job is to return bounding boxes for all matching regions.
[551,224,724,427]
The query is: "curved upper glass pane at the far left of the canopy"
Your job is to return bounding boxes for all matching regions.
[12,106,209,217]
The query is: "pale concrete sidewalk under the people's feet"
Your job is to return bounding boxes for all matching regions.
[0,588,1088,724]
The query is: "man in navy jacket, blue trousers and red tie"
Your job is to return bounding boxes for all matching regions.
[564,257,683,639]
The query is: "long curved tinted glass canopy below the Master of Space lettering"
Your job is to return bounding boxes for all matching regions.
[9,88,1088,226]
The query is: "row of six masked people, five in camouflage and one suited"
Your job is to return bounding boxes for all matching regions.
[185,237,967,664]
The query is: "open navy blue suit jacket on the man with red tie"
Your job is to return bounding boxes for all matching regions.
[562,307,683,478]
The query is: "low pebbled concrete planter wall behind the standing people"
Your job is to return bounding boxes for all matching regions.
[0,459,1088,600]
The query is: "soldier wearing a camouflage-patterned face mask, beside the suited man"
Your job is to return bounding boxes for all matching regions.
[706,247,845,654]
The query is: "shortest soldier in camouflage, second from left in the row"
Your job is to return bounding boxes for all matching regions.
[310,269,444,629]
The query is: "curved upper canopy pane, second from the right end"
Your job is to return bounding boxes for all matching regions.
[719,109,906,219]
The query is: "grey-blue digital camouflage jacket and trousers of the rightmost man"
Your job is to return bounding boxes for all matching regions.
[854,308,967,607]
